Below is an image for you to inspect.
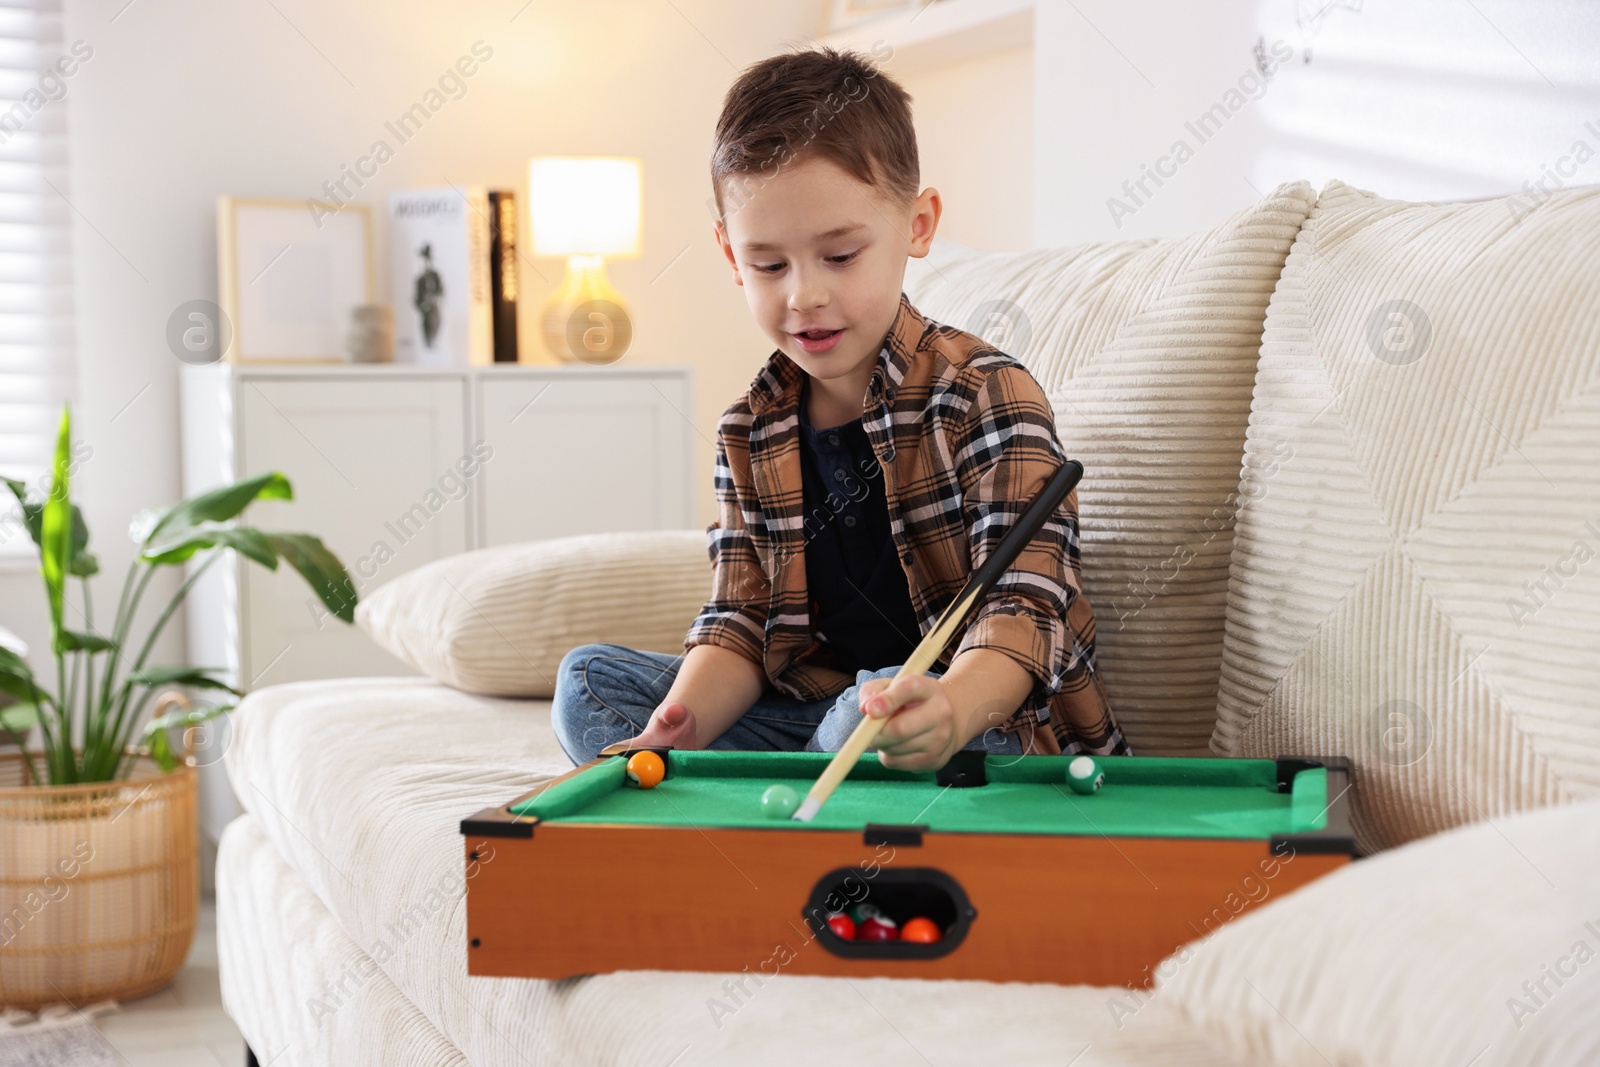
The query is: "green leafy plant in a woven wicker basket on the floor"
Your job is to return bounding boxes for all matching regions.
[0,410,355,1009]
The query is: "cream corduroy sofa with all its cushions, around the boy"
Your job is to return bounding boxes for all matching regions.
[216,182,1600,1067]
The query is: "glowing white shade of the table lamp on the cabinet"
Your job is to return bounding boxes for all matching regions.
[528,155,640,259]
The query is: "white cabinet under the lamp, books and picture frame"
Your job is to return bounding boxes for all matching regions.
[181,363,694,689]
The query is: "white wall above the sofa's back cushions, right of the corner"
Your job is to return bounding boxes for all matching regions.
[1034,0,1600,246]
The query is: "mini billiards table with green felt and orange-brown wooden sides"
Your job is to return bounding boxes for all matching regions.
[461,749,1355,985]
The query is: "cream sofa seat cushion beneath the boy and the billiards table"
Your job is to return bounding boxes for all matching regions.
[218,678,1248,1067]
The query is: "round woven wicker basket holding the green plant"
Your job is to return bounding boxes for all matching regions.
[0,752,200,1009]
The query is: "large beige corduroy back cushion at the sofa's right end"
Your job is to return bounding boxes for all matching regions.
[1213,182,1600,862]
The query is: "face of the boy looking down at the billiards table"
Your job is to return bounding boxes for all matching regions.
[714,157,939,394]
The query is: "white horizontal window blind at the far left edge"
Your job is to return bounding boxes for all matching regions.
[0,0,75,558]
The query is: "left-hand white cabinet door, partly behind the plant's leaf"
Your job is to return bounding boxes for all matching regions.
[238,374,478,689]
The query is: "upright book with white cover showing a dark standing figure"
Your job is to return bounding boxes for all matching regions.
[389,186,494,366]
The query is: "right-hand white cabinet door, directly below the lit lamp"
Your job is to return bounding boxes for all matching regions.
[477,371,694,545]
